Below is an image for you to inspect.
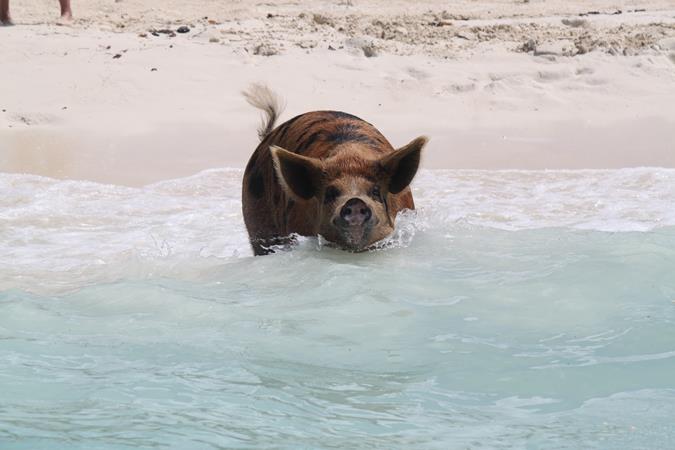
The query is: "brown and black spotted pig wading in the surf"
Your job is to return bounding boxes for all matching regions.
[242,85,427,255]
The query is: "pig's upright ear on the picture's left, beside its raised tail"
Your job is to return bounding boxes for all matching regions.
[270,145,323,200]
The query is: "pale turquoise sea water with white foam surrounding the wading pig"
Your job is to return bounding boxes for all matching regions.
[0,168,675,450]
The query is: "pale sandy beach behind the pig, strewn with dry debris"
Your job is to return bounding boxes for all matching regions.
[0,0,675,186]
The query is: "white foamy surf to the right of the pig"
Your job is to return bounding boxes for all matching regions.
[415,168,675,232]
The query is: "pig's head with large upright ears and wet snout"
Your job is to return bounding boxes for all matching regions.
[270,137,427,251]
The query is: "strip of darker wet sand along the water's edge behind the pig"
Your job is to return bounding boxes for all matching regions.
[0,119,675,187]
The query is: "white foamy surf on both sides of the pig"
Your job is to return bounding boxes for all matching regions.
[0,168,675,290]
